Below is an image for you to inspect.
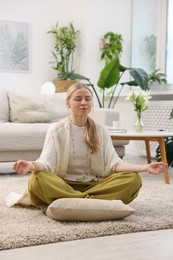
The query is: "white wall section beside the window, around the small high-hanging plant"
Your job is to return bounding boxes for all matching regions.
[80,0,131,84]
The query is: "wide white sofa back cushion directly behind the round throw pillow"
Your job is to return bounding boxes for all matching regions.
[8,92,69,122]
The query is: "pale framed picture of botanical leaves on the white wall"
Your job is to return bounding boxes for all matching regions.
[0,20,30,72]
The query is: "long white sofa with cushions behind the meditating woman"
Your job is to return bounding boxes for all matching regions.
[0,89,128,167]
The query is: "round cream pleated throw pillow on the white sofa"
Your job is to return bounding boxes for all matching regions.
[15,101,52,123]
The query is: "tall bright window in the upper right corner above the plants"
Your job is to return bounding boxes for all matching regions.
[131,0,173,83]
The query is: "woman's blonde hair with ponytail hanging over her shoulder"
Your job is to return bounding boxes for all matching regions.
[66,83,99,154]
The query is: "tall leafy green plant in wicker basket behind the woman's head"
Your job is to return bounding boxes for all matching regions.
[48,22,85,92]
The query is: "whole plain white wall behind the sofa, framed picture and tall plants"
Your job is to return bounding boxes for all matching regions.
[0,0,131,93]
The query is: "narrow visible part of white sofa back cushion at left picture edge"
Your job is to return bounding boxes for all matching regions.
[0,89,9,122]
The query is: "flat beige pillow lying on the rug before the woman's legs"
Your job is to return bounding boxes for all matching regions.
[46,198,134,221]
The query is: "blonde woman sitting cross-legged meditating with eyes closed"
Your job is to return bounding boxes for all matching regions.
[13,83,167,208]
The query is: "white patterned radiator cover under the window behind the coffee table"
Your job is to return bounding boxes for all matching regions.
[136,101,173,156]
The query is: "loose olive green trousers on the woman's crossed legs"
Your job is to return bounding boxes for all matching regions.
[28,171,142,208]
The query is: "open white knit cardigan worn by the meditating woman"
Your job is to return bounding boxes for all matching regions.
[37,118,122,178]
